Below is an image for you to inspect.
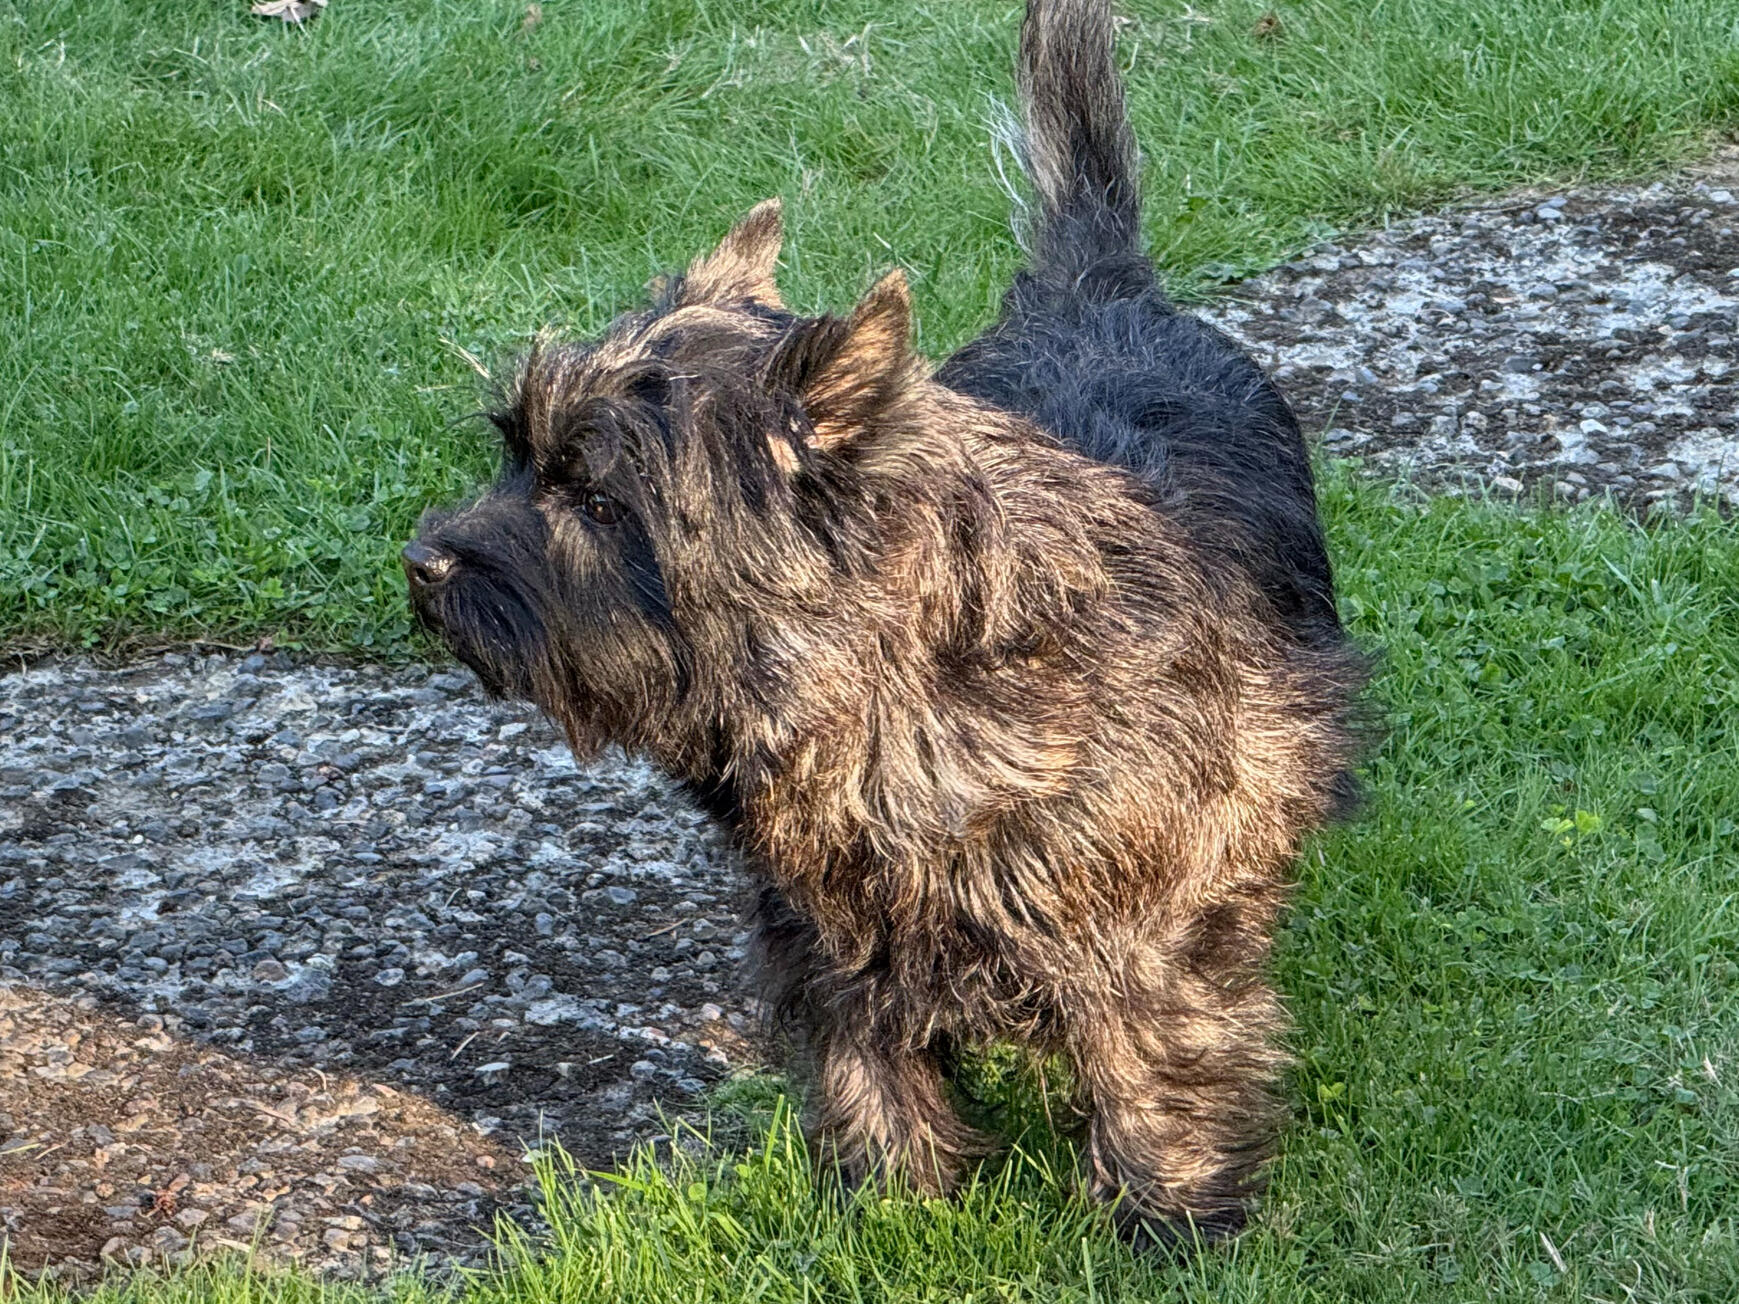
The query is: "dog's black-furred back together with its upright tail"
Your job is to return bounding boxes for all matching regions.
[937,0,1339,642]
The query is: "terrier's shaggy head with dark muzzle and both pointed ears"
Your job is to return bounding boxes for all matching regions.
[403,200,922,753]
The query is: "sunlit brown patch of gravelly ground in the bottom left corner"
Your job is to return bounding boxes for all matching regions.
[0,986,523,1273]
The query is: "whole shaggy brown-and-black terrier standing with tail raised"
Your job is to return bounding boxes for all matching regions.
[407,0,1358,1240]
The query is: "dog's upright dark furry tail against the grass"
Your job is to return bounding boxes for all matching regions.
[1019,0,1153,297]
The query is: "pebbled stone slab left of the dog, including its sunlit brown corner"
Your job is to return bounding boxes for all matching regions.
[0,654,756,1267]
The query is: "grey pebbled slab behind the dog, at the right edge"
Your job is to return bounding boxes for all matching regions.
[1207,153,1739,509]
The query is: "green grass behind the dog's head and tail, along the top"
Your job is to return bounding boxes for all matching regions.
[0,0,1739,650]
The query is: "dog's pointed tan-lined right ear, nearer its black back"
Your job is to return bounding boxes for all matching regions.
[786,269,916,450]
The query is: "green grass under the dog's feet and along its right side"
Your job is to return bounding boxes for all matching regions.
[19,483,1739,1304]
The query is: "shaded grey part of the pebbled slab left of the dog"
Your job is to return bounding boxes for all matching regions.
[0,654,753,1182]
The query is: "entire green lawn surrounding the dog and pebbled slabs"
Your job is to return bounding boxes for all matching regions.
[0,0,1739,1304]
